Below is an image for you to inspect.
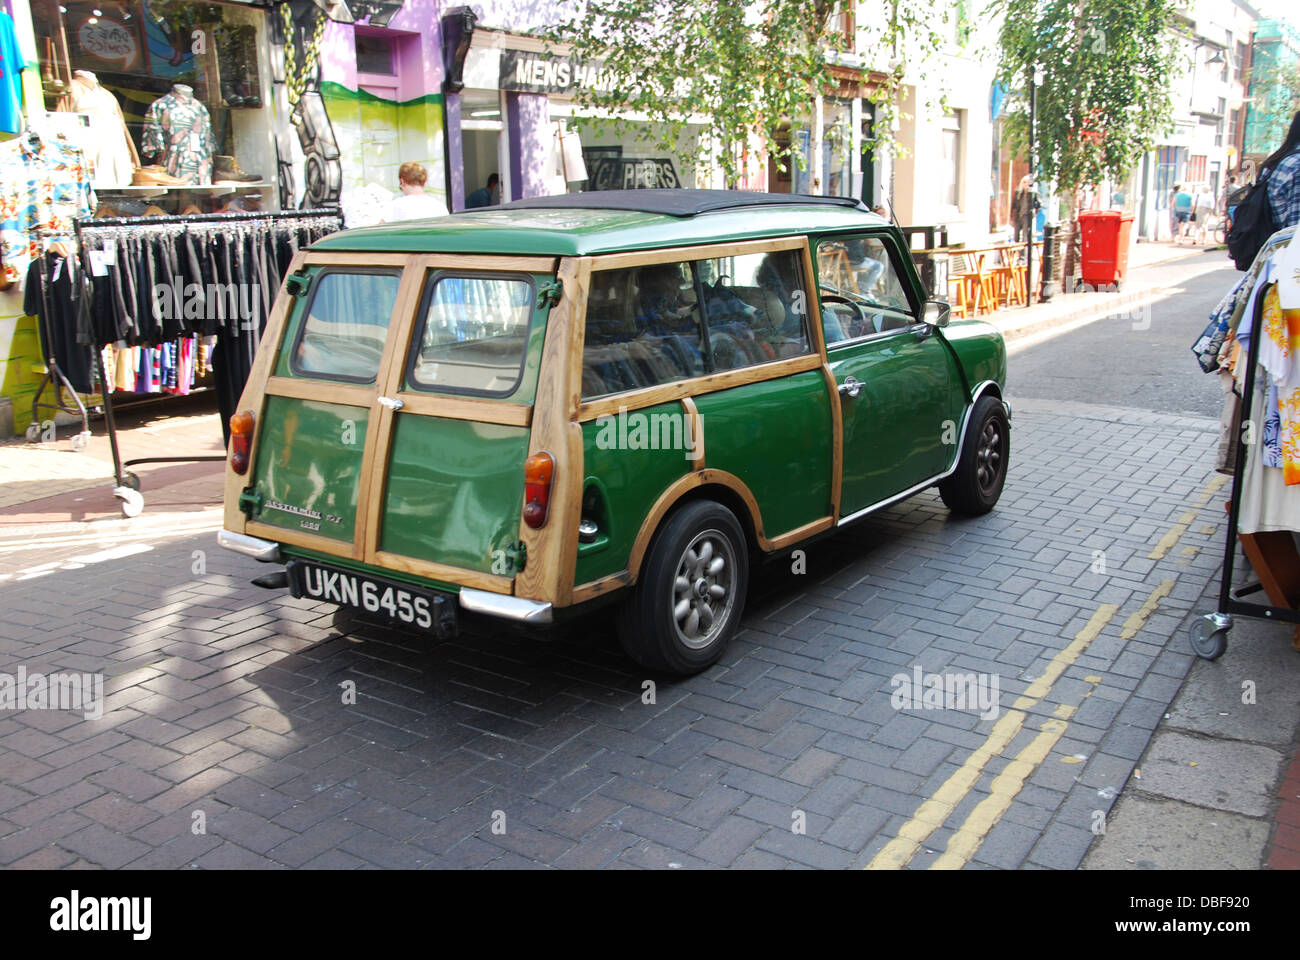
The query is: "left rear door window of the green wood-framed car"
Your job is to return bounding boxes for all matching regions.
[291,271,400,384]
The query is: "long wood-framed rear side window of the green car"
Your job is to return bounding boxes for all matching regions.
[582,250,811,399]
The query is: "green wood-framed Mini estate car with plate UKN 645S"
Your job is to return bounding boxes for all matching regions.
[220,190,1010,674]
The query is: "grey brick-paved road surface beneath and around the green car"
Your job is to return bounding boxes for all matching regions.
[0,392,1226,868]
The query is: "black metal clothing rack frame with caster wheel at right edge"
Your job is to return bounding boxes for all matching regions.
[1190,273,1300,660]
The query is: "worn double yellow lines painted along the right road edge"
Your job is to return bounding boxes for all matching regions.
[866,476,1225,870]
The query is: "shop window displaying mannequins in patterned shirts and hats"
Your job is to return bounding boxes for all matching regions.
[31,0,276,216]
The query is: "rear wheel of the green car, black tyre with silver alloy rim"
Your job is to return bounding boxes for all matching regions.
[618,501,749,676]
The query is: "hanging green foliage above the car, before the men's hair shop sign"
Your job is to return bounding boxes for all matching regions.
[547,0,943,186]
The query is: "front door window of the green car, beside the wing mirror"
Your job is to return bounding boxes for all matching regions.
[818,237,917,345]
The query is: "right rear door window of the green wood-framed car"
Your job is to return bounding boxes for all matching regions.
[408,274,533,397]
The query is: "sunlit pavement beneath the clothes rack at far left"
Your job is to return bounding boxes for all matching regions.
[0,394,224,541]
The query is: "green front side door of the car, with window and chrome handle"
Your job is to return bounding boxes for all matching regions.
[816,230,961,519]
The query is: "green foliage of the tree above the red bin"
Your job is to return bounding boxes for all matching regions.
[993,0,1178,193]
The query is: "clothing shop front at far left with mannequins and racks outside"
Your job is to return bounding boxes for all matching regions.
[0,0,356,432]
